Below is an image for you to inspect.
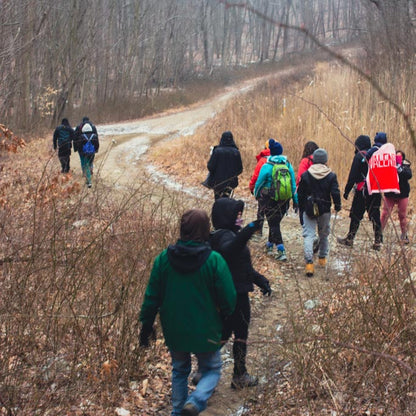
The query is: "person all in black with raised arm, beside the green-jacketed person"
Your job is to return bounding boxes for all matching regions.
[210,198,272,389]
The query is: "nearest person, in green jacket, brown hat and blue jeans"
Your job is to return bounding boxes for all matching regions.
[140,209,236,416]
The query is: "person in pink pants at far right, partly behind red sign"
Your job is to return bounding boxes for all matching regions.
[381,150,412,244]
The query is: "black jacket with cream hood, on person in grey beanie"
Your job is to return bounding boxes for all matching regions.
[298,164,341,214]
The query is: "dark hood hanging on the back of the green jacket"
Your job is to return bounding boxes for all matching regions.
[167,240,212,273]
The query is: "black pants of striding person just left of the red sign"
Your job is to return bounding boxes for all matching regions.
[347,189,383,243]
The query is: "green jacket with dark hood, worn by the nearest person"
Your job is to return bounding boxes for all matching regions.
[140,240,236,353]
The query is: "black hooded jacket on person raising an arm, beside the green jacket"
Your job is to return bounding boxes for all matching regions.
[210,198,269,293]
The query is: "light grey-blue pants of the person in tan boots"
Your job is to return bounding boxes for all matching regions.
[303,212,331,263]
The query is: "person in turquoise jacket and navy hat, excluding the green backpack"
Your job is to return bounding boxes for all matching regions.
[254,139,298,261]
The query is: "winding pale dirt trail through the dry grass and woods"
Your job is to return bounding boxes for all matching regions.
[93,66,376,416]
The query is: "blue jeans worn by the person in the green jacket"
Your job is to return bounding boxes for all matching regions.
[170,350,222,416]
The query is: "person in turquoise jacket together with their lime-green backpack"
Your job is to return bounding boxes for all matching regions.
[254,139,298,261]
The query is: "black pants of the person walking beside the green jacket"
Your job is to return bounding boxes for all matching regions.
[222,293,251,376]
